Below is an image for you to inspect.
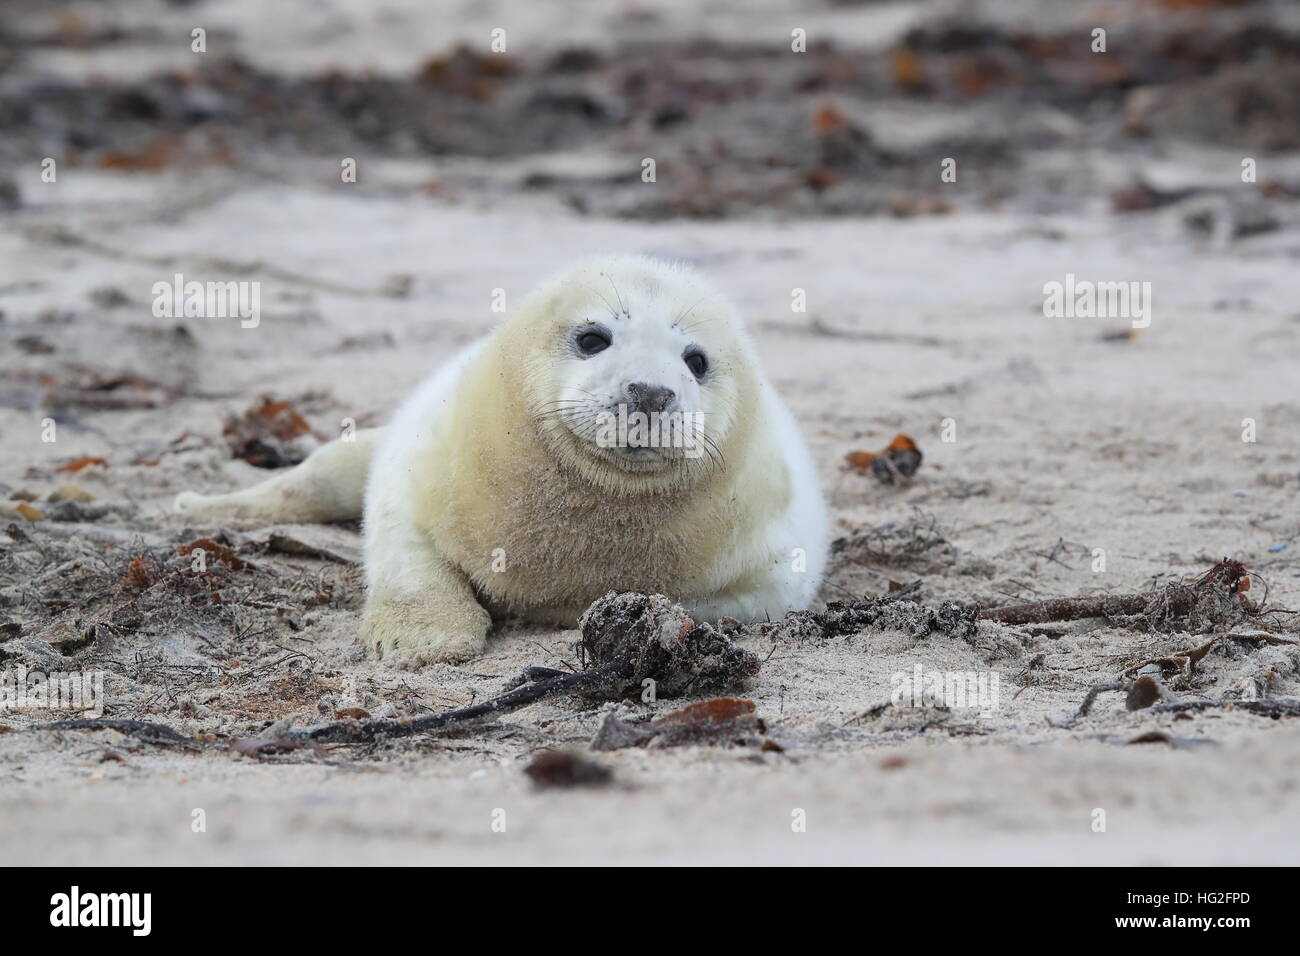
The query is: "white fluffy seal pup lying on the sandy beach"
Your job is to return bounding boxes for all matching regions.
[176,258,828,665]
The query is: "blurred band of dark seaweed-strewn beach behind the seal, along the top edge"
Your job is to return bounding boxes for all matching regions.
[0,0,1300,221]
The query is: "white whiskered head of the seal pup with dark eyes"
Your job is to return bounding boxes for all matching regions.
[511,258,758,490]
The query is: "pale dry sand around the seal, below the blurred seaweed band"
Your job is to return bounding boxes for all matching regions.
[0,185,1300,862]
